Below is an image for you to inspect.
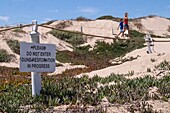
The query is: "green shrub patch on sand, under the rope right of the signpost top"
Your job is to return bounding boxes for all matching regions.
[49,30,85,46]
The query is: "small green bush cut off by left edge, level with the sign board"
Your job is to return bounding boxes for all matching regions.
[0,49,15,62]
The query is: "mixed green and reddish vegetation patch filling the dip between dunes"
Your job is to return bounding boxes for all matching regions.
[56,37,144,70]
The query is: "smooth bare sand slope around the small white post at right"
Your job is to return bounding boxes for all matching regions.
[78,39,170,77]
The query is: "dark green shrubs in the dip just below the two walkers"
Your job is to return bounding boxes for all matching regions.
[93,37,144,58]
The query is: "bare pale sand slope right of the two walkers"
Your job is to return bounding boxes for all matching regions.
[131,16,170,37]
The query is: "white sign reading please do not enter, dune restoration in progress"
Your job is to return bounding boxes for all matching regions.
[20,42,56,72]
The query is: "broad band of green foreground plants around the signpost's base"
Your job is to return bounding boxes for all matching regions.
[0,74,170,113]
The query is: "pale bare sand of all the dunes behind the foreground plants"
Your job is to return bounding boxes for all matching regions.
[0,17,170,76]
